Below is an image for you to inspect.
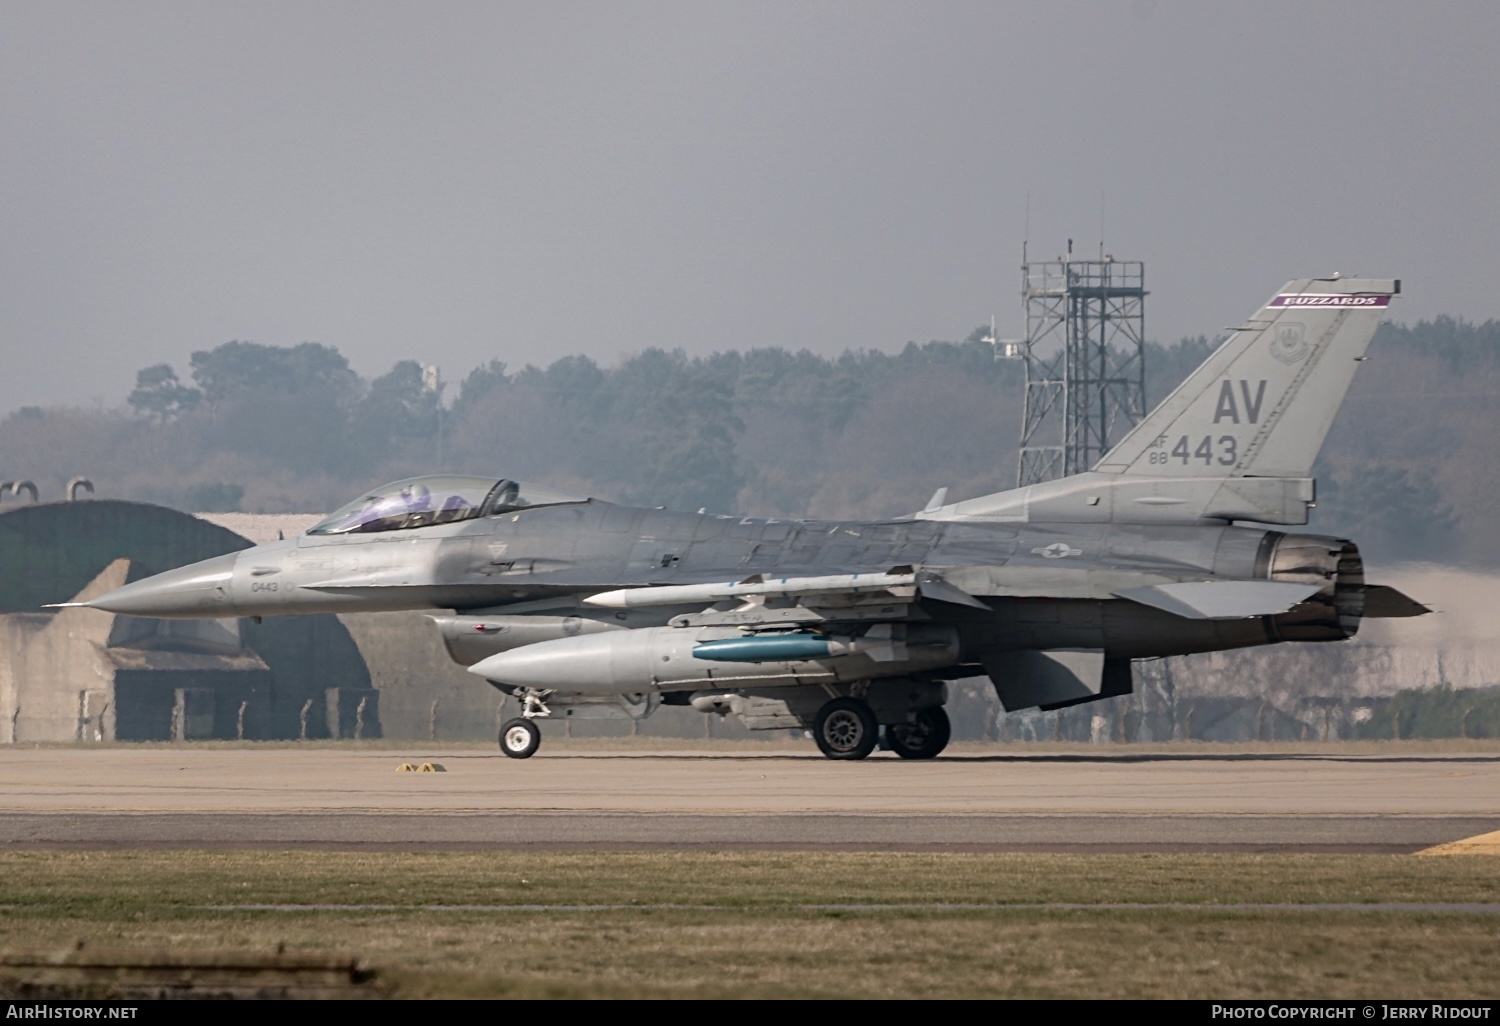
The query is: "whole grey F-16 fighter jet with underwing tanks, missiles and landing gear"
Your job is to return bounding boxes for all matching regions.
[73,278,1428,759]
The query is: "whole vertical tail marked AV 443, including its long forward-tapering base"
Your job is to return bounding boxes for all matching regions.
[915,278,1401,524]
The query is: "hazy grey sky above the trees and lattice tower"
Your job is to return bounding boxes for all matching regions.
[0,0,1500,414]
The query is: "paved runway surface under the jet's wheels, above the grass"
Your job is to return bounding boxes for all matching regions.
[0,744,1500,852]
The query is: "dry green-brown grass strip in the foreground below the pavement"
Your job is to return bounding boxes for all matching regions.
[0,851,1500,999]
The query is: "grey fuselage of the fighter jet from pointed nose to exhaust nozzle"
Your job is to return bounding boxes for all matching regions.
[93,500,1362,669]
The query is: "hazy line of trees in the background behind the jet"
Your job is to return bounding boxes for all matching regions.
[0,318,1500,564]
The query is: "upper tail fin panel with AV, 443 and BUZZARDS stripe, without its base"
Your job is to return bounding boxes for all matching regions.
[1094,278,1401,477]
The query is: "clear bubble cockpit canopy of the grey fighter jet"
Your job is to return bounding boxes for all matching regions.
[308,477,588,534]
